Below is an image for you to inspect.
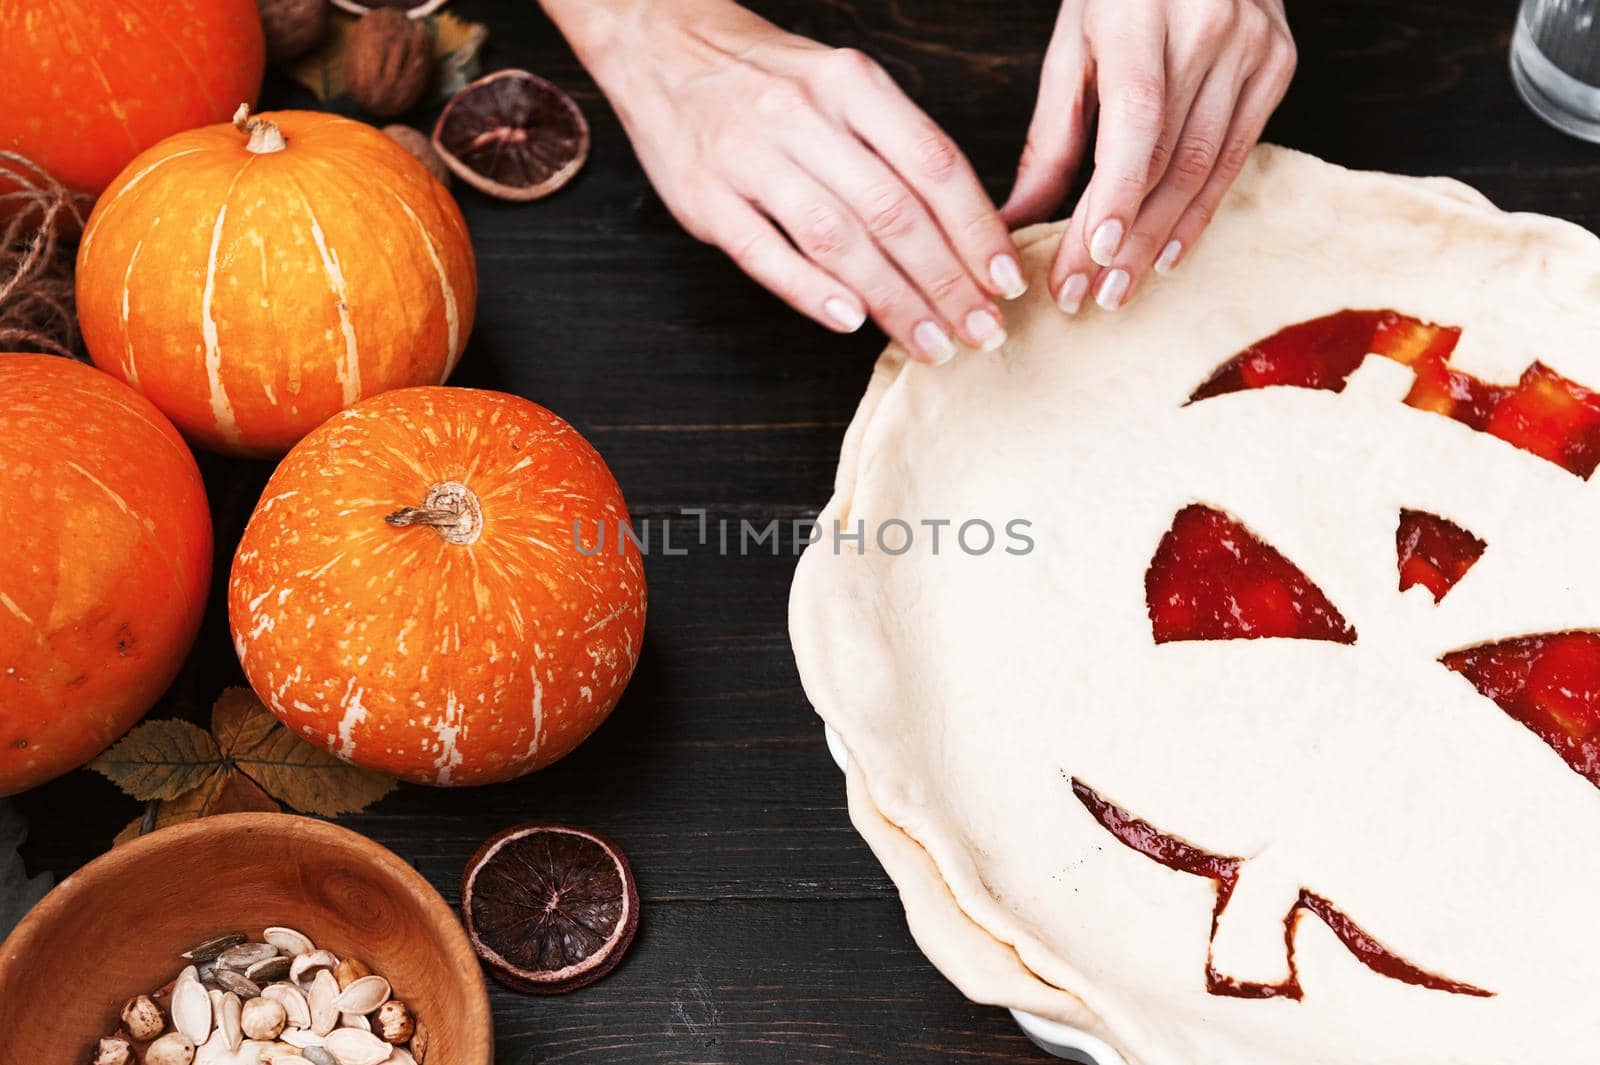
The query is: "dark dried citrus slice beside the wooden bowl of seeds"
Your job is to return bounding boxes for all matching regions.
[461,825,638,995]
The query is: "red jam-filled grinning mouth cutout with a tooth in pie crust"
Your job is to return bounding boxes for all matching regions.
[1072,780,1493,1001]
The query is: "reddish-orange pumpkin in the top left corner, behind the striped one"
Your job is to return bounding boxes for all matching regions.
[0,0,266,195]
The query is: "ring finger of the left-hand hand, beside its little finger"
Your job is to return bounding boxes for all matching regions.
[746,167,955,365]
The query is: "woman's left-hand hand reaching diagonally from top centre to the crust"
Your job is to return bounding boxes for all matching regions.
[546,0,1026,363]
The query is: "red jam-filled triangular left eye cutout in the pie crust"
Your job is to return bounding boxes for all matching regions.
[1144,504,1355,643]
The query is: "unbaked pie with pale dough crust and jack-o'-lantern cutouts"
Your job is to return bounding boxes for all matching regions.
[790,147,1600,1065]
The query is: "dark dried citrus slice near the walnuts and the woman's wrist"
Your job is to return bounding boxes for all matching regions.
[434,70,589,200]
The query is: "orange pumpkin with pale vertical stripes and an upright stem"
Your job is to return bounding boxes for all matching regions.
[77,110,477,454]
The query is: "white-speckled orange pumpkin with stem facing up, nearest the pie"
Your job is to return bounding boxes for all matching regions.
[227,389,645,785]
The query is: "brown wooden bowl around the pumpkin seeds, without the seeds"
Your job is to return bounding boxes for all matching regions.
[0,814,494,1065]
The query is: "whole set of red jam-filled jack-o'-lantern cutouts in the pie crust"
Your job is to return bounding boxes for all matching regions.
[1074,310,1600,999]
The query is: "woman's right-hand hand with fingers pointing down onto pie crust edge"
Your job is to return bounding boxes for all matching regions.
[1002,0,1294,313]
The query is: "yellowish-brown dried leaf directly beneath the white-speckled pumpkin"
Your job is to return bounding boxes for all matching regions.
[220,688,395,817]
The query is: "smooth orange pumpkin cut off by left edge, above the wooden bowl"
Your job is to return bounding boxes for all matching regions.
[0,355,211,795]
